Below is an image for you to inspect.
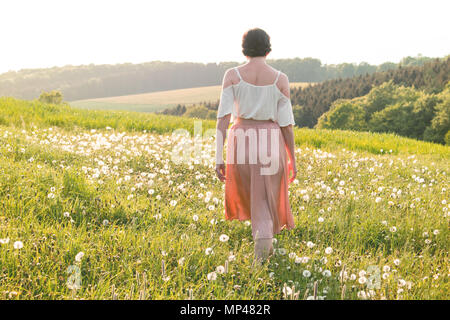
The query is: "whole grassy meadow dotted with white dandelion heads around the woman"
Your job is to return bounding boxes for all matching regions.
[0,98,450,300]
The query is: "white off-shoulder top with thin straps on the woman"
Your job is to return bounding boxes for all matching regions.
[217,67,295,127]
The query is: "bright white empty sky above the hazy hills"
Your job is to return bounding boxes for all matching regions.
[0,0,450,73]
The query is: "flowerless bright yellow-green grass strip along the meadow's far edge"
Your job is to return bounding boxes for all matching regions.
[0,98,450,159]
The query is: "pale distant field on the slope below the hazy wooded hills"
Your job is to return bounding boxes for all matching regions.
[70,82,309,112]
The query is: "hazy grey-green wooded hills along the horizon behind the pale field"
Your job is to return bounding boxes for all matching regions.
[0,55,431,101]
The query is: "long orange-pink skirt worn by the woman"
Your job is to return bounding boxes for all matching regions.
[224,119,295,239]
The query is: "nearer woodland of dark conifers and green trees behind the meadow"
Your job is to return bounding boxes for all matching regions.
[160,57,450,144]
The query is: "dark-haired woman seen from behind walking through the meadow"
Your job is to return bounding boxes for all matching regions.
[216,28,297,262]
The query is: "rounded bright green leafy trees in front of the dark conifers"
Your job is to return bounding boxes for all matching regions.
[316,80,450,145]
